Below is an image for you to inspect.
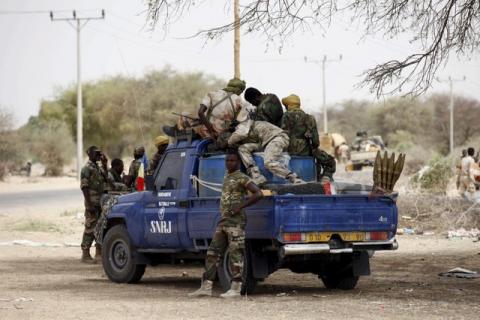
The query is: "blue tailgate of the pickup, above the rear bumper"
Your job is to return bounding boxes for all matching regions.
[275,195,397,242]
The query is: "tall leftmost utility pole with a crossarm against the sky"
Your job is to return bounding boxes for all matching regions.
[50,9,105,180]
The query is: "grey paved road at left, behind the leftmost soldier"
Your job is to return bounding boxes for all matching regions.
[0,188,83,213]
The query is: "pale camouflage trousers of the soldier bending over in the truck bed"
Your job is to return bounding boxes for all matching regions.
[238,134,291,178]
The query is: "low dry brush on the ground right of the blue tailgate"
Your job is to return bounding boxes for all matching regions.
[397,194,480,232]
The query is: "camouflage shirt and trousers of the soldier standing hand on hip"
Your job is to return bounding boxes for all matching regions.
[203,170,251,281]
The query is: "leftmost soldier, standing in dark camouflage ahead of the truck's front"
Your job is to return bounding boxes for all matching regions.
[80,146,105,263]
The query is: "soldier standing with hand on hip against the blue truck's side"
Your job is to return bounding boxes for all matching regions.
[189,152,263,298]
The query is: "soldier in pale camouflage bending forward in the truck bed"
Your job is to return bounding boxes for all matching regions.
[228,113,304,185]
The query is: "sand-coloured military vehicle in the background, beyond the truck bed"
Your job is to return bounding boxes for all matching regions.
[345,130,385,171]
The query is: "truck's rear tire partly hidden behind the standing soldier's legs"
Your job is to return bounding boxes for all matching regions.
[217,242,257,295]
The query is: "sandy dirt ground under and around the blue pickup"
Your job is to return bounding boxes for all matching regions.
[0,179,480,320]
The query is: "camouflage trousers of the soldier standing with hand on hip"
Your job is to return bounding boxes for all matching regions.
[203,224,245,281]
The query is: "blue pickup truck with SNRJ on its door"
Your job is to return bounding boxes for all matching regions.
[99,136,398,293]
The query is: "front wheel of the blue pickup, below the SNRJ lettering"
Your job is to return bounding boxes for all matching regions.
[102,224,145,283]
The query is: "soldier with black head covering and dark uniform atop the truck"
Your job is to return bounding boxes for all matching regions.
[245,88,283,127]
